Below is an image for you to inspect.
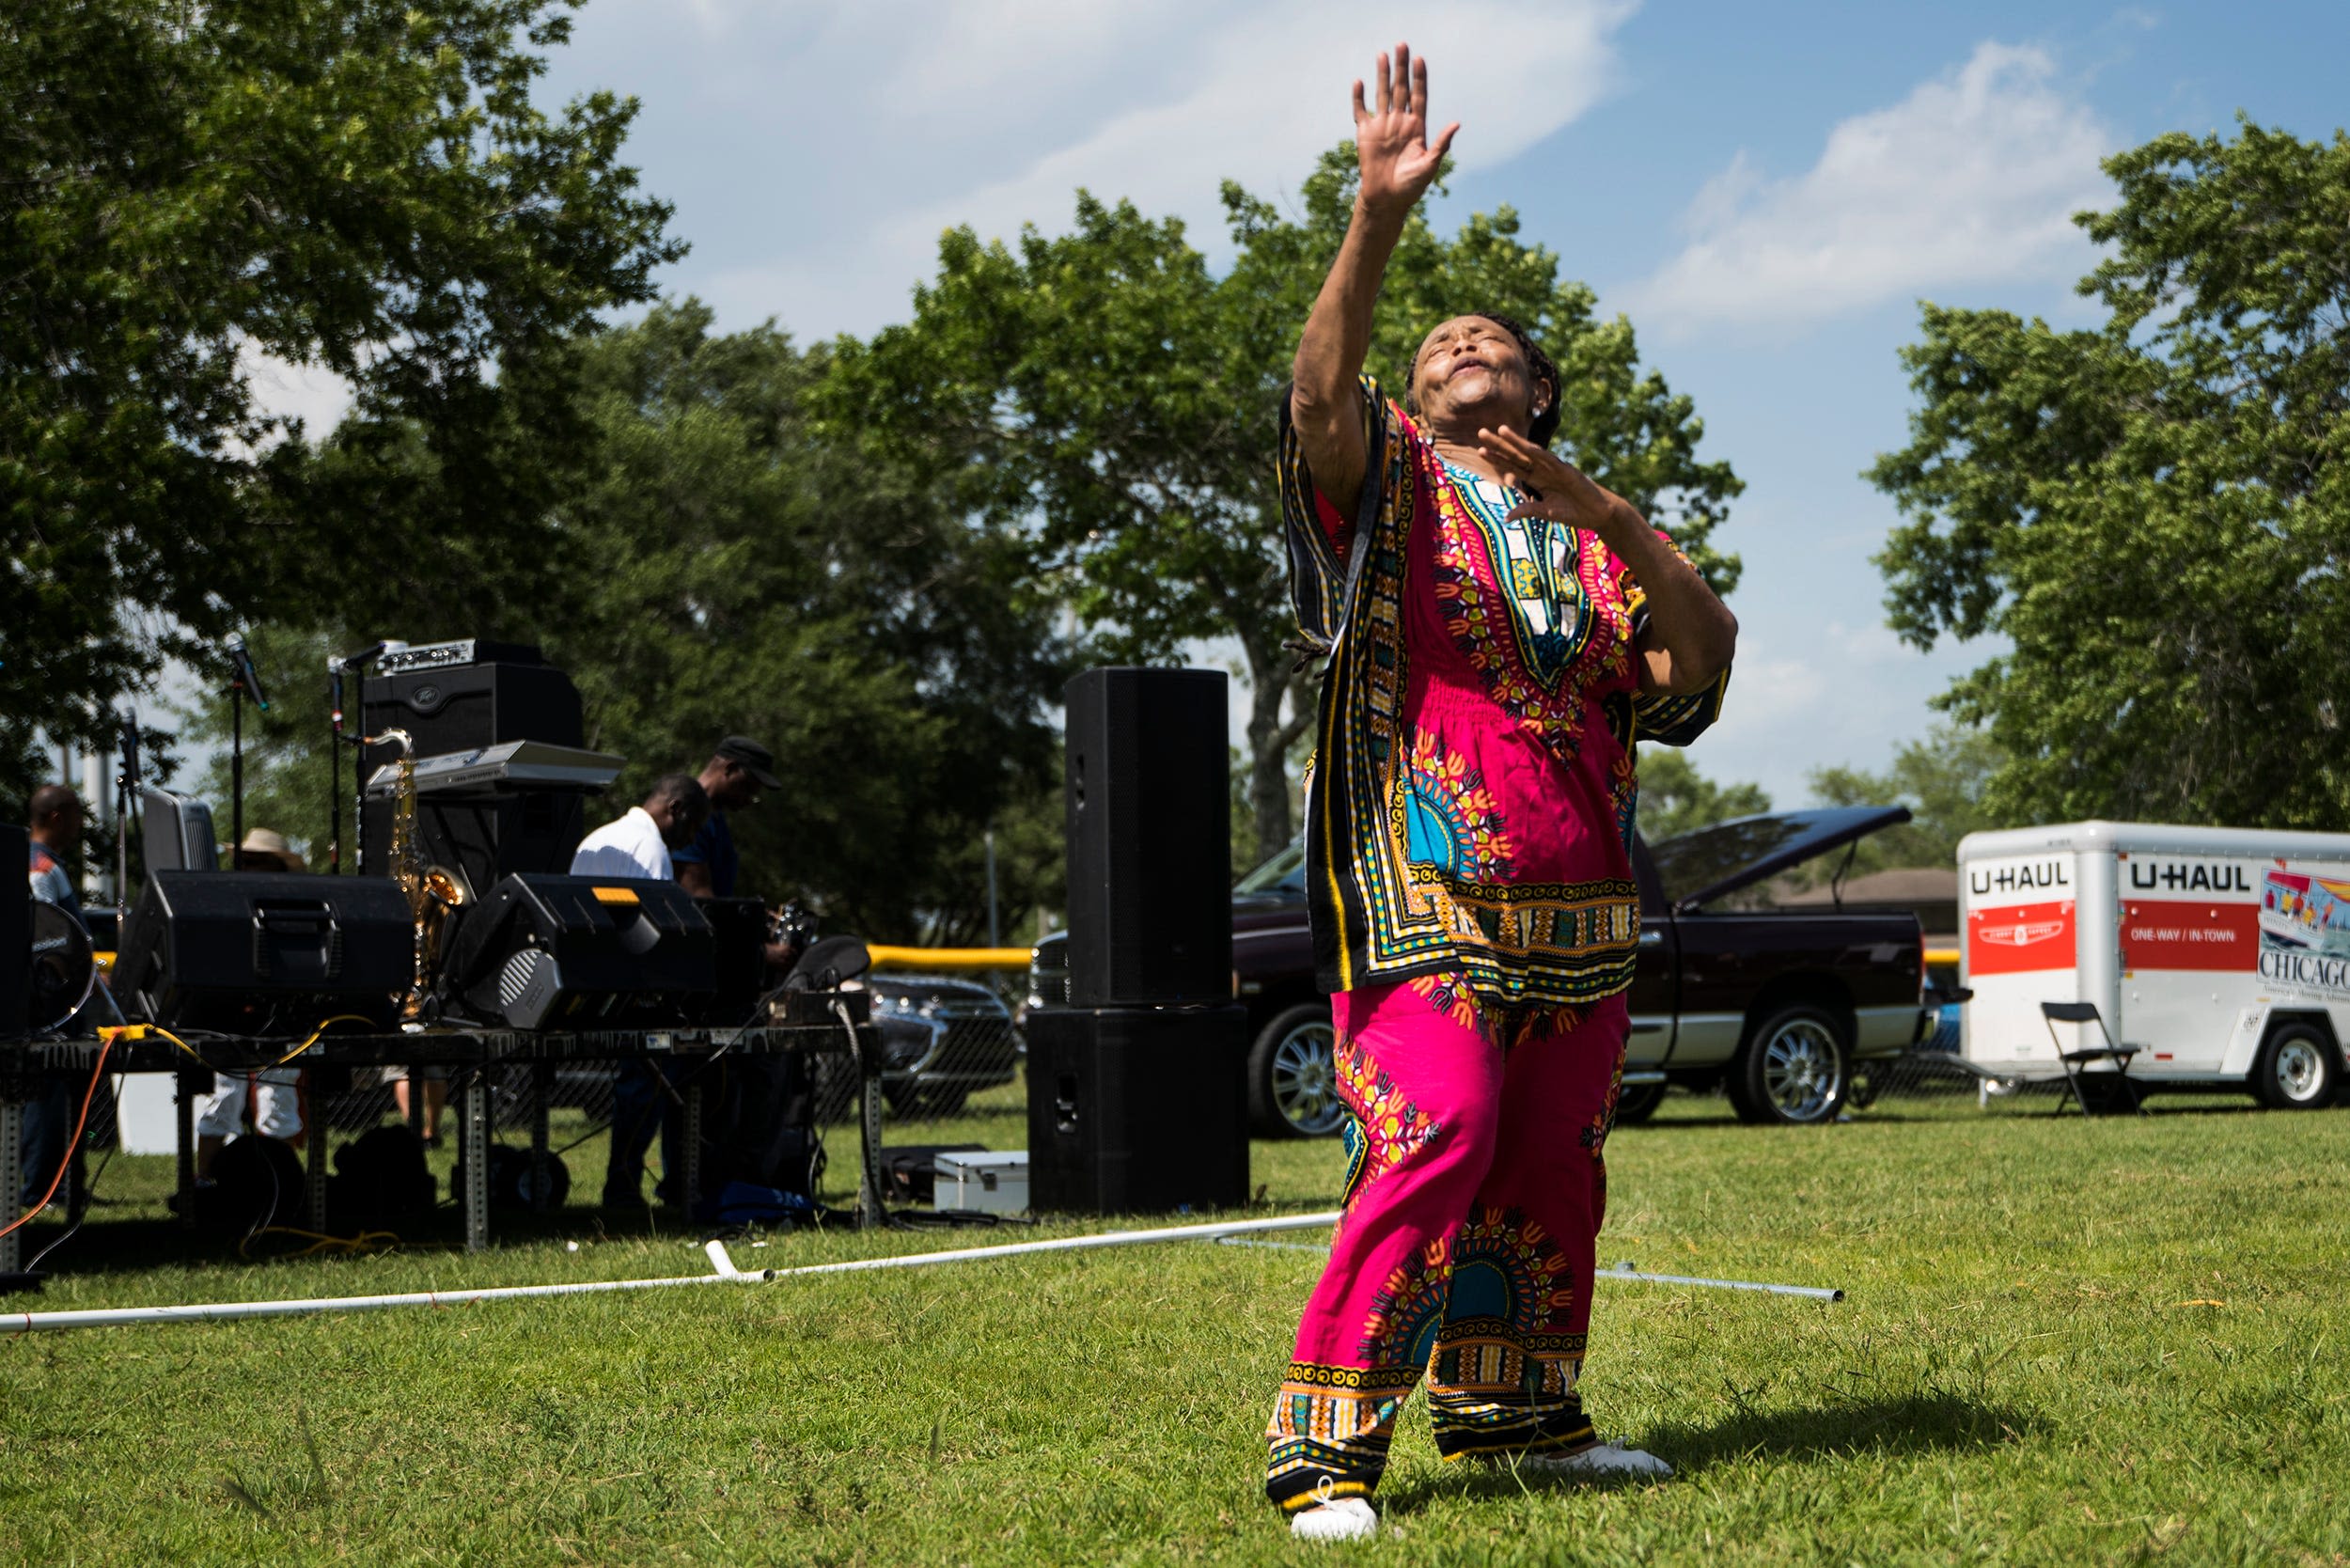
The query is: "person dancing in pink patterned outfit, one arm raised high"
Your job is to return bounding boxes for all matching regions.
[1264,45,1737,1540]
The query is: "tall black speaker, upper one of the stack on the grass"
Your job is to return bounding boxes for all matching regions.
[1067,670,1231,1006]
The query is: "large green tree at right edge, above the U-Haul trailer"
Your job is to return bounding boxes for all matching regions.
[1869,120,2350,827]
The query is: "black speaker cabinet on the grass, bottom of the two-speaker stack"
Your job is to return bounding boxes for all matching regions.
[1027,1006,1248,1213]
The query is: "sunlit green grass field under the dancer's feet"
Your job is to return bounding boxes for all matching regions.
[0,1095,2350,1565]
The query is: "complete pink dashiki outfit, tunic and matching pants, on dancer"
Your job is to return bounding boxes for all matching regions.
[1264,376,1728,1512]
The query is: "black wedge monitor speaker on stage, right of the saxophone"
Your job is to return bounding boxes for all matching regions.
[440,874,717,1029]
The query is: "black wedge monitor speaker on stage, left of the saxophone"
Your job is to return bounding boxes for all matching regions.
[113,872,416,1034]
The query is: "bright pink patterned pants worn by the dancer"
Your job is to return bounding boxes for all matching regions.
[1264,982,1629,1512]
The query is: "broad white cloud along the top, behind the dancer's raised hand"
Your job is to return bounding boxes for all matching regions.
[550,0,1636,338]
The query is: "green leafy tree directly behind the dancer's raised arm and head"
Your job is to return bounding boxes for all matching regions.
[835,146,1742,865]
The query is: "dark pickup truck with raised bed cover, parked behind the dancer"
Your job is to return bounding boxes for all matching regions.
[1029,807,1935,1137]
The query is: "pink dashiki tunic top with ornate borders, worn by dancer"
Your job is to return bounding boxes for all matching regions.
[1281,379,1720,1039]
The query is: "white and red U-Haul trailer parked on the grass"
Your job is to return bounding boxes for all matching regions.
[1958,823,2350,1107]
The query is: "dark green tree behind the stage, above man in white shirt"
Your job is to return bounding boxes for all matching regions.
[180,301,1067,943]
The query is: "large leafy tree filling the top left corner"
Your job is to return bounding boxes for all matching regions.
[0,0,682,808]
